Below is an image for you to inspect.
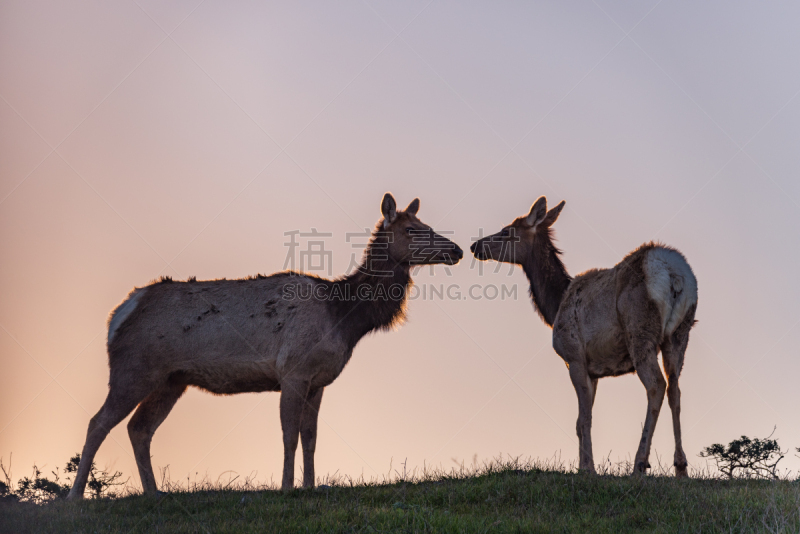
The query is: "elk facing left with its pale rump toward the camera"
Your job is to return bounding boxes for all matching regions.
[470,197,697,477]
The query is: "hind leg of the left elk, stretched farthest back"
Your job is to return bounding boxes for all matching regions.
[67,386,144,500]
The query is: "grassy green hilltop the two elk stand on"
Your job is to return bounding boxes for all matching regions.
[0,461,800,533]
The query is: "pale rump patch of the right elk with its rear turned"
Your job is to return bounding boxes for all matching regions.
[644,247,697,336]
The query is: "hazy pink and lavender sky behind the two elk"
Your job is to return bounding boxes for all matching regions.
[0,0,800,485]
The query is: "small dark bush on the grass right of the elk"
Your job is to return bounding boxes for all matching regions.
[700,430,788,480]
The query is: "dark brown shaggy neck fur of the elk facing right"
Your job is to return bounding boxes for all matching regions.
[330,229,412,347]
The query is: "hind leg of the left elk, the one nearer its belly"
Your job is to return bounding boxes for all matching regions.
[128,384,186,495]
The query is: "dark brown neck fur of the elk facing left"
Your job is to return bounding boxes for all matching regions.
[522,228,572,327]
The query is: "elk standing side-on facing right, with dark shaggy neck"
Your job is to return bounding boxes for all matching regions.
[69,193,463,499]
